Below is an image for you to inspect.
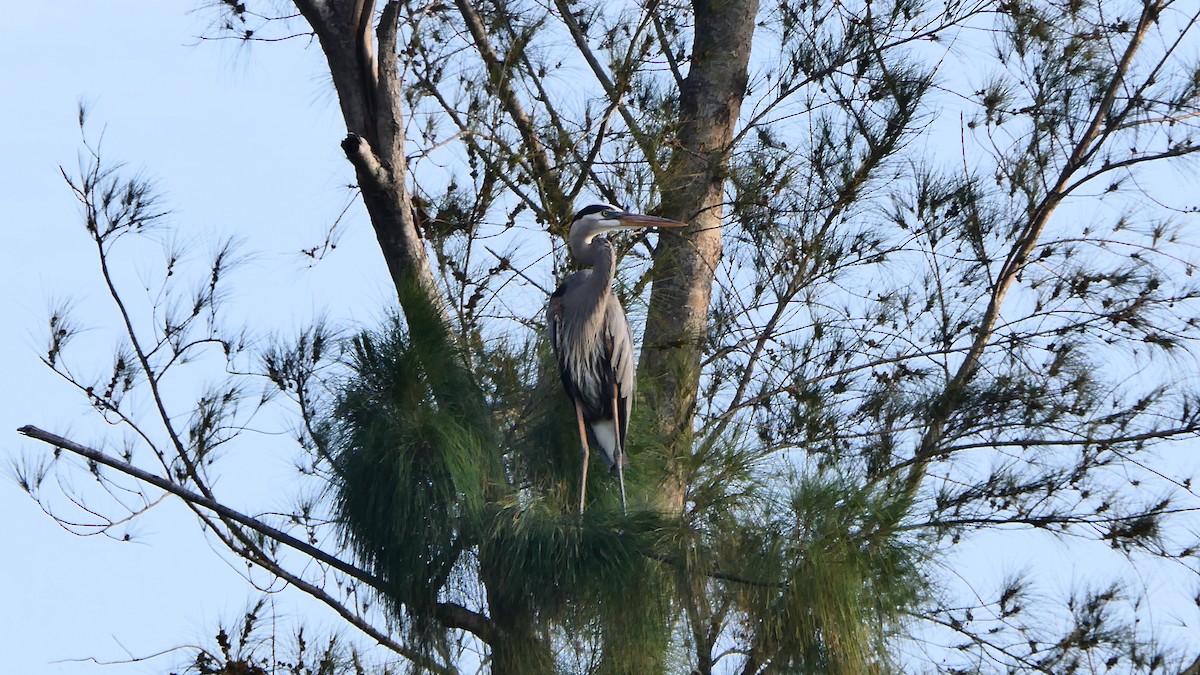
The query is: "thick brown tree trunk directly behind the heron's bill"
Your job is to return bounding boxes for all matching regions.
[638,0,758,510]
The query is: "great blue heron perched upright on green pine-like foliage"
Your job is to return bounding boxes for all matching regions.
[546,204,685,513]
